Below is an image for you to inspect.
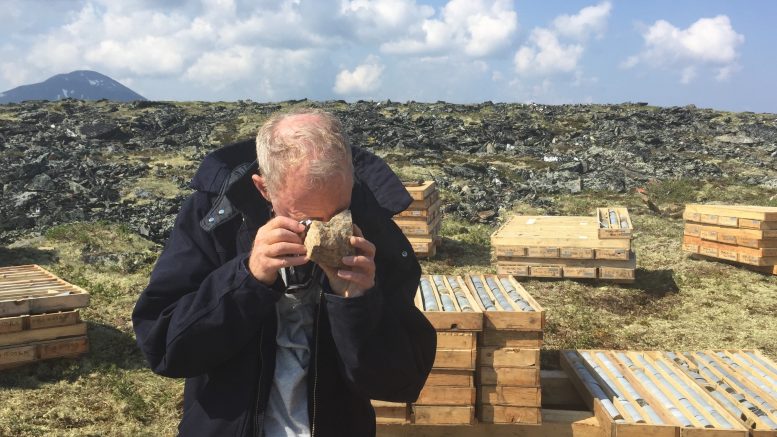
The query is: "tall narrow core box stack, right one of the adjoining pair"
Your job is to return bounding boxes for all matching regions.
[465,275,545,425]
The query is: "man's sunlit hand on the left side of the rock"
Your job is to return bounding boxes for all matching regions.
[248,217,308,285]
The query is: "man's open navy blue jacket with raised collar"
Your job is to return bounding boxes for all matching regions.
[132,141,436,436]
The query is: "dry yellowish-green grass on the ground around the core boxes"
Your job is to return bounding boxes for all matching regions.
[6,186,777,436]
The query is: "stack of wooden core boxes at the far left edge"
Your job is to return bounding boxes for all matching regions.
[0,265,89,370]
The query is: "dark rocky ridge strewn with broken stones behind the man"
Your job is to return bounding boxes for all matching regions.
[0,100,777,242]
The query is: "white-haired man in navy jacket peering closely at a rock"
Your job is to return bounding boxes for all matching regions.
[132,110,436,437]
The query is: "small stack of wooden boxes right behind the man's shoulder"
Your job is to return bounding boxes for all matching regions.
[394,181,442,258]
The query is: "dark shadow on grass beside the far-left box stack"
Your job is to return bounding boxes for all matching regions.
[0,322,146,388]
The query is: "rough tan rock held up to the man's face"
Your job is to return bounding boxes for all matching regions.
[305,210,356,268]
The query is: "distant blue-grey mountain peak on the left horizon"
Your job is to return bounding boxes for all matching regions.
[0,70,146,104]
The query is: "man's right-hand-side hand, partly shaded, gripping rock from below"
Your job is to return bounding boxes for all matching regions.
[321,225,375,297]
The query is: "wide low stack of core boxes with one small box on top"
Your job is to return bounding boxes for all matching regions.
[491,208,637,282]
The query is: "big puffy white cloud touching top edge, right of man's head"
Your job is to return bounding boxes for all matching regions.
[381,0,518,57]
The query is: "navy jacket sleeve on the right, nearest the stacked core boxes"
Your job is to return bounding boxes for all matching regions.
[325,219,437,402]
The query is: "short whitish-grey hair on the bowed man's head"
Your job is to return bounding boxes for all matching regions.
[256,108,353,191]
